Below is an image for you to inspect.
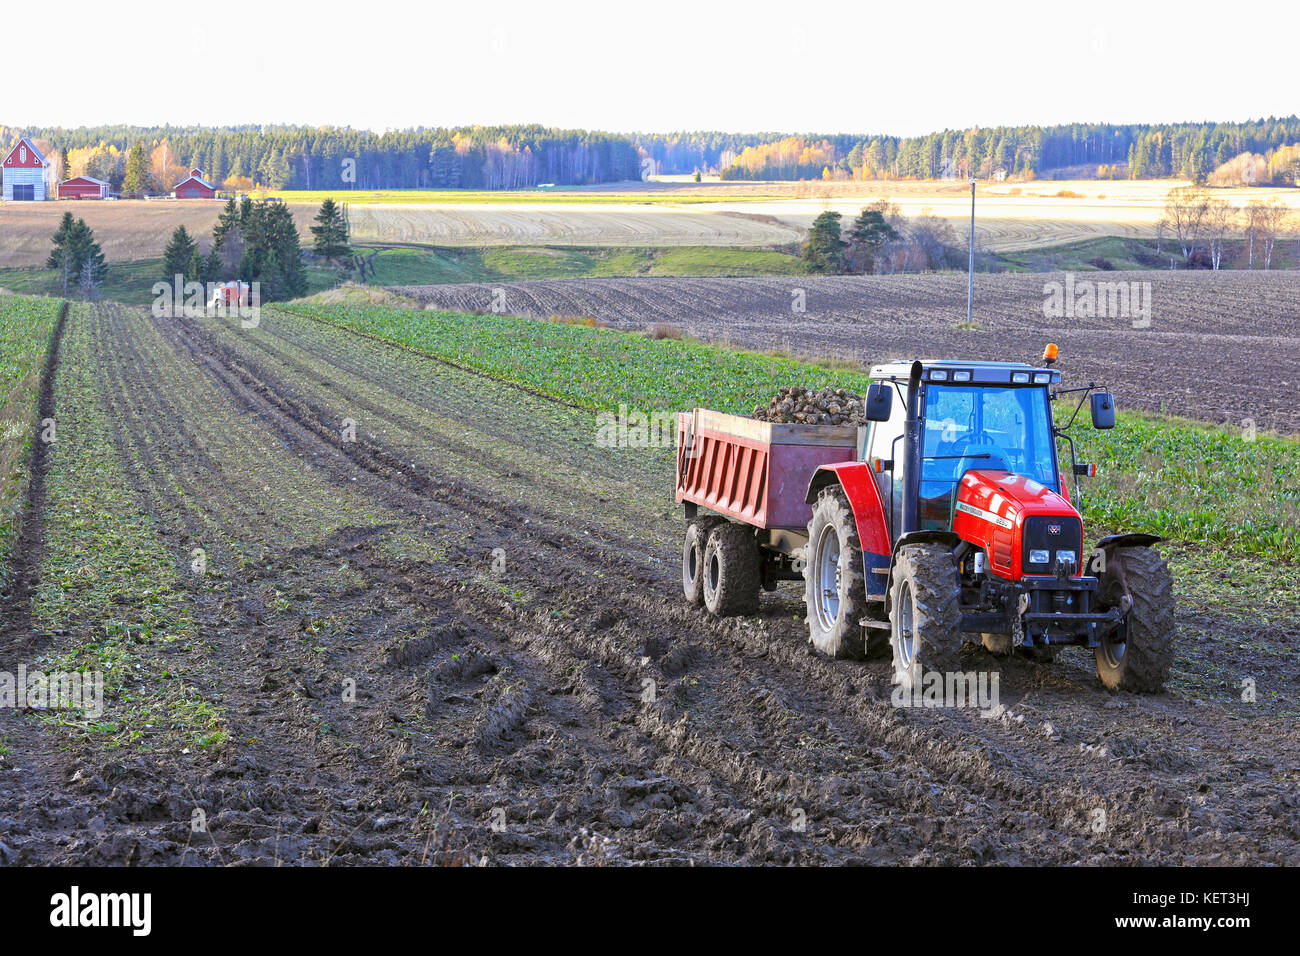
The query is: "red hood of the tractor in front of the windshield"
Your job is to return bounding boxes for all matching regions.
[953,468,1083,580]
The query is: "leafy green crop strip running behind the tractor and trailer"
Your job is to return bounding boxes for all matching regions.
[274,306,1300,561]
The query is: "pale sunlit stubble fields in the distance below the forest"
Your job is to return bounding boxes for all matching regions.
[0,179,1300,267]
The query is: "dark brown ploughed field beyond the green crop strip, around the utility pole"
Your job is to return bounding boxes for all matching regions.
[400,272,1300,433]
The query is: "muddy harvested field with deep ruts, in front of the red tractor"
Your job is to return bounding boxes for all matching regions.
[0,304,1300,865]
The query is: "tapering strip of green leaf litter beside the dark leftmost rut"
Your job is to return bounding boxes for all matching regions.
[33,306,225,749]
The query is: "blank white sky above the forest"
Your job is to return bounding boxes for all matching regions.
[10,0,1300,135]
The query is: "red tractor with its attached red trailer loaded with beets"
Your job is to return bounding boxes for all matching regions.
[676,346,1174,692]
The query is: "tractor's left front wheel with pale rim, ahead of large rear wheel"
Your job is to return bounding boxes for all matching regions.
[889,544,962,691]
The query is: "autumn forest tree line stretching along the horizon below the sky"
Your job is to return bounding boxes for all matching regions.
[0,116,1300,193]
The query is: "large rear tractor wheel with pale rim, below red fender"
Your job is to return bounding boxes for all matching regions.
[803,485,887,659]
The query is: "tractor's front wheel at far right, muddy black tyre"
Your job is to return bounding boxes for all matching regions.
[1093,548,1175,693]
